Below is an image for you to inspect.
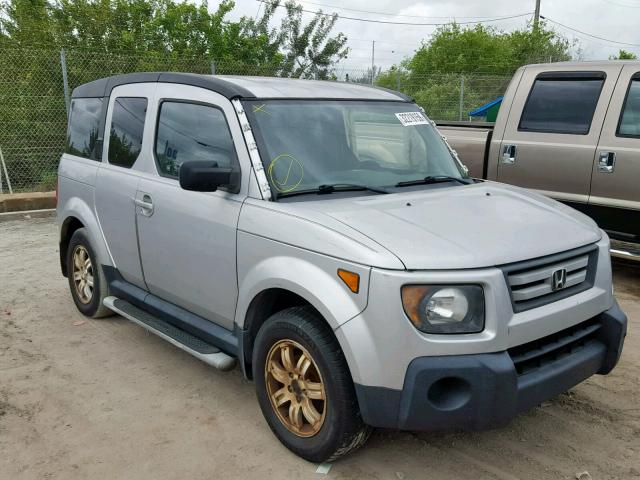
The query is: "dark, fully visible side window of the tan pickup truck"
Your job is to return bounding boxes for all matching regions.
[518,74,605,135]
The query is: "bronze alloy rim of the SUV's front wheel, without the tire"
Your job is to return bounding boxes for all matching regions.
[264,340,327,437]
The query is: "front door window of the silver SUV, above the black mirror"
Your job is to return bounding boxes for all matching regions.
[156,102,235,177]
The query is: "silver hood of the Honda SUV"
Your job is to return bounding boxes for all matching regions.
[299,182,601,270]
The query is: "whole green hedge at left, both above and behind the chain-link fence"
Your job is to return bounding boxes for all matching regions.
[0,0,348,189]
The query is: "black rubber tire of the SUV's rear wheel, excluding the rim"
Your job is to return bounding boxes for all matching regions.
[66,228,114,318]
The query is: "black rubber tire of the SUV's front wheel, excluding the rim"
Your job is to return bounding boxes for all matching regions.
[253,307,372,463]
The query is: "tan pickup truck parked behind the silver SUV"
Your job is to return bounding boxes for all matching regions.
[440,61,640,260]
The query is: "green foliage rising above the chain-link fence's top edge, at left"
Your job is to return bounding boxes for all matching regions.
[0,0,348,72]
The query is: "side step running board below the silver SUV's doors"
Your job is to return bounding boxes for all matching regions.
[103,297,236,371]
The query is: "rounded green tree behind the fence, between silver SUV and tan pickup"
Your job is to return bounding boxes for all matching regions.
[376,22,575,120]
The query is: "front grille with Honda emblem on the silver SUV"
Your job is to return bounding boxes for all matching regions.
[502,246,597,312]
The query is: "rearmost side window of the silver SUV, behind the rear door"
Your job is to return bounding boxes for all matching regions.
[65,98,103,160]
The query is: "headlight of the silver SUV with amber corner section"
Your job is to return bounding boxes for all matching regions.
[402,285,484,333]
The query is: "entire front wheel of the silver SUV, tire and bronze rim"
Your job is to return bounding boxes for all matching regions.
[253,307,372,462]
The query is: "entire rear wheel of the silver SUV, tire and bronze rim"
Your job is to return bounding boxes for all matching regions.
[67,228,113,318]
